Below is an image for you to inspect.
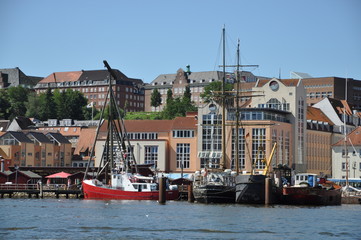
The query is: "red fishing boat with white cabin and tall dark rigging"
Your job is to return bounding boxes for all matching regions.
[82,61,179,200]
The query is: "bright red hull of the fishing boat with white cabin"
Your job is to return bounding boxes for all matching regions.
[82,182,179,200]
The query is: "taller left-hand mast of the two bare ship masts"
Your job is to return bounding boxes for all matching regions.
[220,26,226,169]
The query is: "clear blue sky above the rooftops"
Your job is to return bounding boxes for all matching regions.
[0,0,361,83]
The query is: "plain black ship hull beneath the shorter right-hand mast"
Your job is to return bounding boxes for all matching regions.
[235,175,266,204]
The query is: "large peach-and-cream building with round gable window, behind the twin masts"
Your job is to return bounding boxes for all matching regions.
[198,78,306,172]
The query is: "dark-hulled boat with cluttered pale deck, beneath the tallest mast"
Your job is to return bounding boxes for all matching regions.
[193,169,235,203]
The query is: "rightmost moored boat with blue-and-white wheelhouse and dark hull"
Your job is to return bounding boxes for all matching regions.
[281,173,341,205]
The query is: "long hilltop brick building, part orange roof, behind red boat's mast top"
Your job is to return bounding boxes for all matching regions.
[35,69,144,112]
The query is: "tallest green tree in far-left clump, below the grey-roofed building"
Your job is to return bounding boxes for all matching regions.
[7,86,29,119]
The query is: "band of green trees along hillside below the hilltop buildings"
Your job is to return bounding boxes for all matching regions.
[0,81,233,121]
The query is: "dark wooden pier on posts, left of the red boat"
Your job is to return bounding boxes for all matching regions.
[0,184,82,198]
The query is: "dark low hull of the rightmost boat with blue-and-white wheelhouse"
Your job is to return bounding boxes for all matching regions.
[282,187,341,205]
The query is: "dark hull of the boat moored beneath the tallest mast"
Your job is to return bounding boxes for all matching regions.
[193,184,235,203]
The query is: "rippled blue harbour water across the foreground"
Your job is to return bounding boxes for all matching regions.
[0,198,361,239]
